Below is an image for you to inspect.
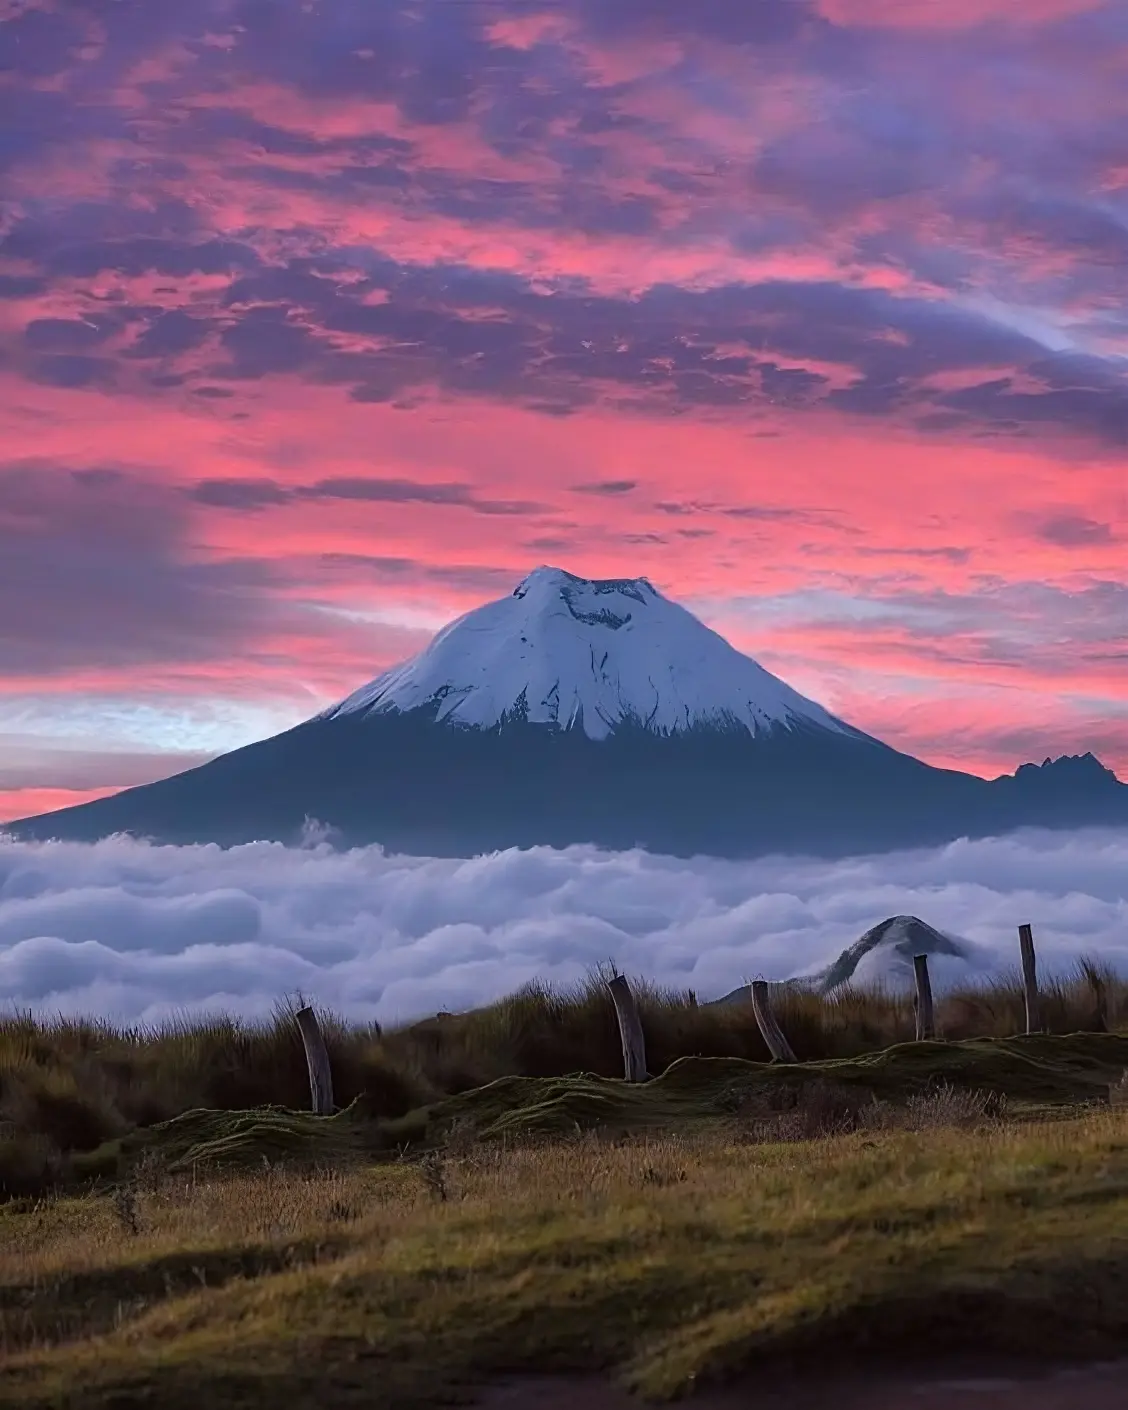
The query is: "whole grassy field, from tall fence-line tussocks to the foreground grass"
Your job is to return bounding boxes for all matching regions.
[0,971,1128,1410]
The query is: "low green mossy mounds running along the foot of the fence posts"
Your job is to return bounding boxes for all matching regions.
[99,1034,1128,1175]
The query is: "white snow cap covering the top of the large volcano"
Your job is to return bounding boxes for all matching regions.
[324,567,854,739]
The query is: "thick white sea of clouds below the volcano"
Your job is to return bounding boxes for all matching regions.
[0,830,1128,1022]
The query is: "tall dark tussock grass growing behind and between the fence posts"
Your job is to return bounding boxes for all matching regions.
[0,962,1128,1199]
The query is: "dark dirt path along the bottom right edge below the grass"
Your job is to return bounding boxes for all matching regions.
[477,1361,1128,1410]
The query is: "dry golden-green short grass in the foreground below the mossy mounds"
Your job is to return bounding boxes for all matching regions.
[0,1090,1128,1410]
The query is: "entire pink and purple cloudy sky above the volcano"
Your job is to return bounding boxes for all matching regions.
[0,0,1128,818]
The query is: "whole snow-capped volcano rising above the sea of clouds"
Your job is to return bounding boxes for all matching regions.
[8,568,1128,856]
